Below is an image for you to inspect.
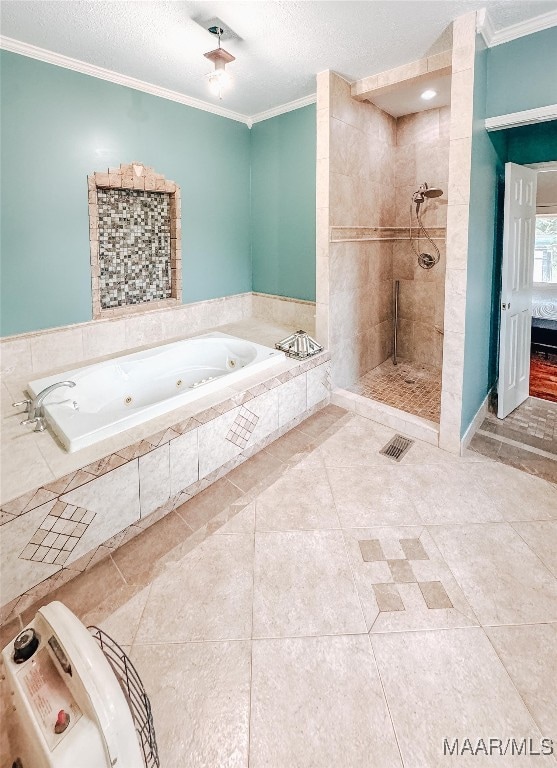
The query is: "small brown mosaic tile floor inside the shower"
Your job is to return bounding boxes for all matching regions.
[348,359,441,423]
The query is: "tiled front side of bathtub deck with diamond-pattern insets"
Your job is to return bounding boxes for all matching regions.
[1,328,330,611]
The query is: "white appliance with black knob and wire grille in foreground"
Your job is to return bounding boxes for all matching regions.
[1,601,156,768]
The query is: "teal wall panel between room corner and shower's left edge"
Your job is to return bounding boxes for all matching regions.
[251,104,316,301]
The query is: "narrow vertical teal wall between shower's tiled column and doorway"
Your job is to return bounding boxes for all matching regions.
[461,38,503,435]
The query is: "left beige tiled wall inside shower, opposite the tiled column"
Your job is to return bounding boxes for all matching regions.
[324,73,396,384]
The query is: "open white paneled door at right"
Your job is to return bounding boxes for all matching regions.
[497,158,537,419]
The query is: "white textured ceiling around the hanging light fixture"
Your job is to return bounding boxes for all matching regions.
[1,0,557,115]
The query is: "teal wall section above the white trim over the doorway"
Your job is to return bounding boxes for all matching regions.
[486,27,557,117]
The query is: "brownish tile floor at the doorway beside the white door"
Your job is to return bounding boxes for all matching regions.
[470,397,557,482]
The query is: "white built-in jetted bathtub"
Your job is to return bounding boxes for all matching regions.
[28,333,284,453]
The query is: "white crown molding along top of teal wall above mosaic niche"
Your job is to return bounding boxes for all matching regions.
[0,35,250,125]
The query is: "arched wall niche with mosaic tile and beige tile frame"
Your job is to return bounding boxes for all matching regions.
[88,163,182,319]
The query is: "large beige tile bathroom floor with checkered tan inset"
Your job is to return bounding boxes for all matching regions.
[0,406,557,768]
